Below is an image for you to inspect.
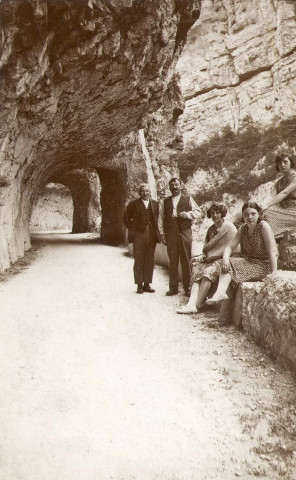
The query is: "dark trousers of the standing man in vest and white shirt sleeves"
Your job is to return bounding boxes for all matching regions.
[167,221,192,292]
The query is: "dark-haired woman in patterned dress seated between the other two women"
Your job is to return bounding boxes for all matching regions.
[204,202,277,305]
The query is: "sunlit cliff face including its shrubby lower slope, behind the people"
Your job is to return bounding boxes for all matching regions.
[177,0,296,228]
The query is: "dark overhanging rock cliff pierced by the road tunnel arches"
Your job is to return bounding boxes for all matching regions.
[0,0,200,271]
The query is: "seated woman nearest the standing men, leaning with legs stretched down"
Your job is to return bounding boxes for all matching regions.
[176,202,236,313]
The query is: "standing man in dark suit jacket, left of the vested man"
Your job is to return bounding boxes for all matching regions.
[122,183,160,293]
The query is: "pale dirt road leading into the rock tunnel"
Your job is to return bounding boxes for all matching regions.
[0,234,296,480]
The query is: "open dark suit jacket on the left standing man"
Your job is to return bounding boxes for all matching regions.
[122,198,160,243]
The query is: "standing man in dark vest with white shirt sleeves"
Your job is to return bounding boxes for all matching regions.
[159,177,200,297]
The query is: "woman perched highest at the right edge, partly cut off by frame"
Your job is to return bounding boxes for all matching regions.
[262,154,296,239]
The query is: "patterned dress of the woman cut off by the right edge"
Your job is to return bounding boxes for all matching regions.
[264,170,296,238]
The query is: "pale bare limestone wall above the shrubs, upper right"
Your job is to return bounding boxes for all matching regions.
[178,0,296,144]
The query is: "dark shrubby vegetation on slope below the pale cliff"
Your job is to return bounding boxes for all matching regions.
[175,116,296,204]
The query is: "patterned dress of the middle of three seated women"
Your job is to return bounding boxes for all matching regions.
[203,221,276,285]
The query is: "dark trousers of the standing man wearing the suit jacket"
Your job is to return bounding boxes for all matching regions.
[133,225,156,284]
